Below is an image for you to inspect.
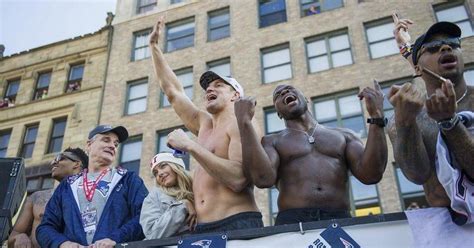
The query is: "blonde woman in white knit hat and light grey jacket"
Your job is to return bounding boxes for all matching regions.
[140,153,197,239]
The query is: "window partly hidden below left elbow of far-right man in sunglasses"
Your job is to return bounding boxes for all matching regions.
[395,165,428,210]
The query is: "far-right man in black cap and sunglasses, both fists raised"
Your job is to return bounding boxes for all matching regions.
[388,16,474,247]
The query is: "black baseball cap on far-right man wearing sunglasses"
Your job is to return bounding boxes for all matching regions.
[411,22,461,65]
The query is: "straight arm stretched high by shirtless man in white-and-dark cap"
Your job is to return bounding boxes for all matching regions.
[149,17,208,135]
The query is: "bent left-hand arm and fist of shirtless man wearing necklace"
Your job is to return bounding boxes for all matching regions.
[234,98,280,188]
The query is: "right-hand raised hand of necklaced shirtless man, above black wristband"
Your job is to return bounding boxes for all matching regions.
[357,80,384,118]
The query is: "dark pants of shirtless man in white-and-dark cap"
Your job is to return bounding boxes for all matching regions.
[194,212,263,234]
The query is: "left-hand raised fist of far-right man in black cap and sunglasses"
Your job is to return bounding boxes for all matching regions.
[387,83,425,126]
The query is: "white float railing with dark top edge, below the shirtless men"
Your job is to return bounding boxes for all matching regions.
[116,213,413,248]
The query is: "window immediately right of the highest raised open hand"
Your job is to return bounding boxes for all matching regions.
[166,18,194,52]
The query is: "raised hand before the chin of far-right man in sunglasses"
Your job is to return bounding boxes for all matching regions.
[425,79,457,121]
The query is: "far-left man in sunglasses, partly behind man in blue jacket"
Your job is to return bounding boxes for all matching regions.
[8,148,88,248]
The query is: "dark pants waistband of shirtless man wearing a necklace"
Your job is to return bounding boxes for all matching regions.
[275,208,351,226]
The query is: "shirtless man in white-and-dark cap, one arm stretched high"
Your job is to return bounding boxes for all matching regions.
[150,18,263,233]
